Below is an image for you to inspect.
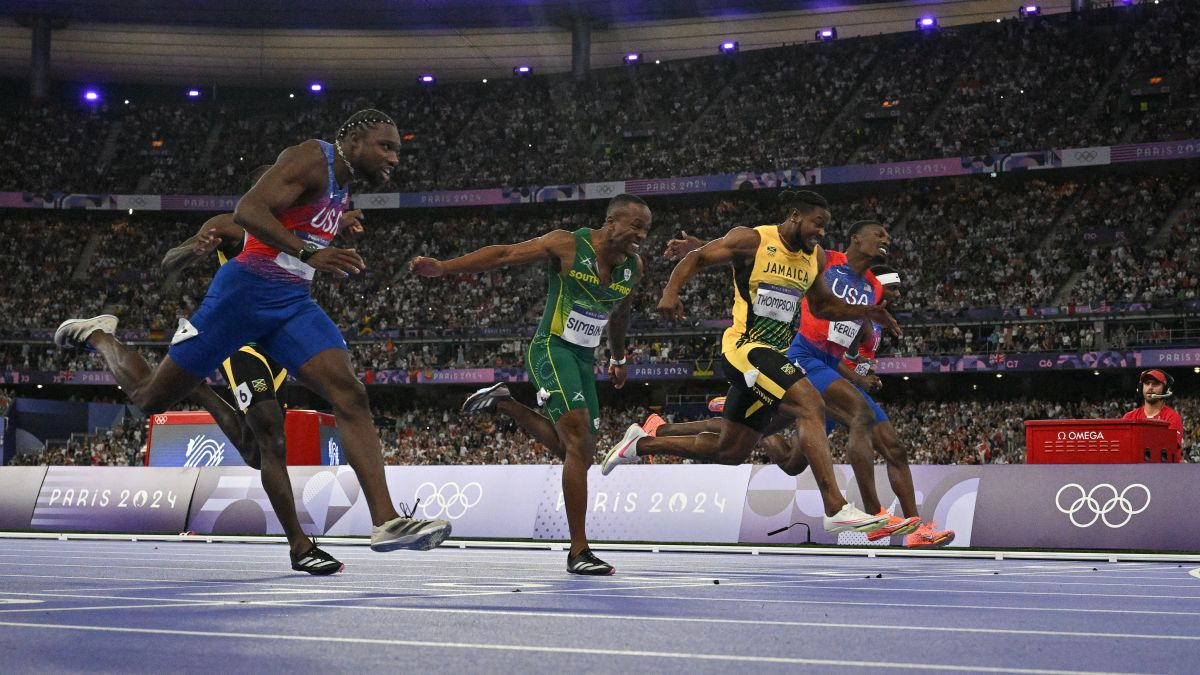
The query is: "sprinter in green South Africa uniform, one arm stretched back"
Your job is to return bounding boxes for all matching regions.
[409,195,650,575]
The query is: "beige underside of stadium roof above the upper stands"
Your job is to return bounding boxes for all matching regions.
[0,0,1060,89]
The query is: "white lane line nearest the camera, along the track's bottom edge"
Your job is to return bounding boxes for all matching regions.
[0,621,1142,675]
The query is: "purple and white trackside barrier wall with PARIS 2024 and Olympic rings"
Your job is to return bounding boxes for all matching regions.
[0,465,1200,551]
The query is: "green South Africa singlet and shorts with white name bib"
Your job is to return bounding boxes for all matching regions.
[526,227,637,434]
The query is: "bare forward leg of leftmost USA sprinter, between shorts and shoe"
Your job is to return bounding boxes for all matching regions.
[295,348,400,525]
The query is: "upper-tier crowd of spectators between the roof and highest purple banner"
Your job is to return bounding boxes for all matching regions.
[0,0,1200,193]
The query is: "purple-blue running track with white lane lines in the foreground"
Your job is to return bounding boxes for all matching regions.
[0,539,1200,675]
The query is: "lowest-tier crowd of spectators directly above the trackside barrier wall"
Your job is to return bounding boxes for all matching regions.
[7,398,1200,466]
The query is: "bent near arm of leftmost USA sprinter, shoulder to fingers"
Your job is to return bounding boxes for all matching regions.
[233,141,366,274]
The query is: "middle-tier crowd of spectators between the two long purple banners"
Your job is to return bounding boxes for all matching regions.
[0,168,1200,370]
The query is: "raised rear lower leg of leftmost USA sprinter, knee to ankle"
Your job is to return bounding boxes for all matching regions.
[88,330,202,414]
